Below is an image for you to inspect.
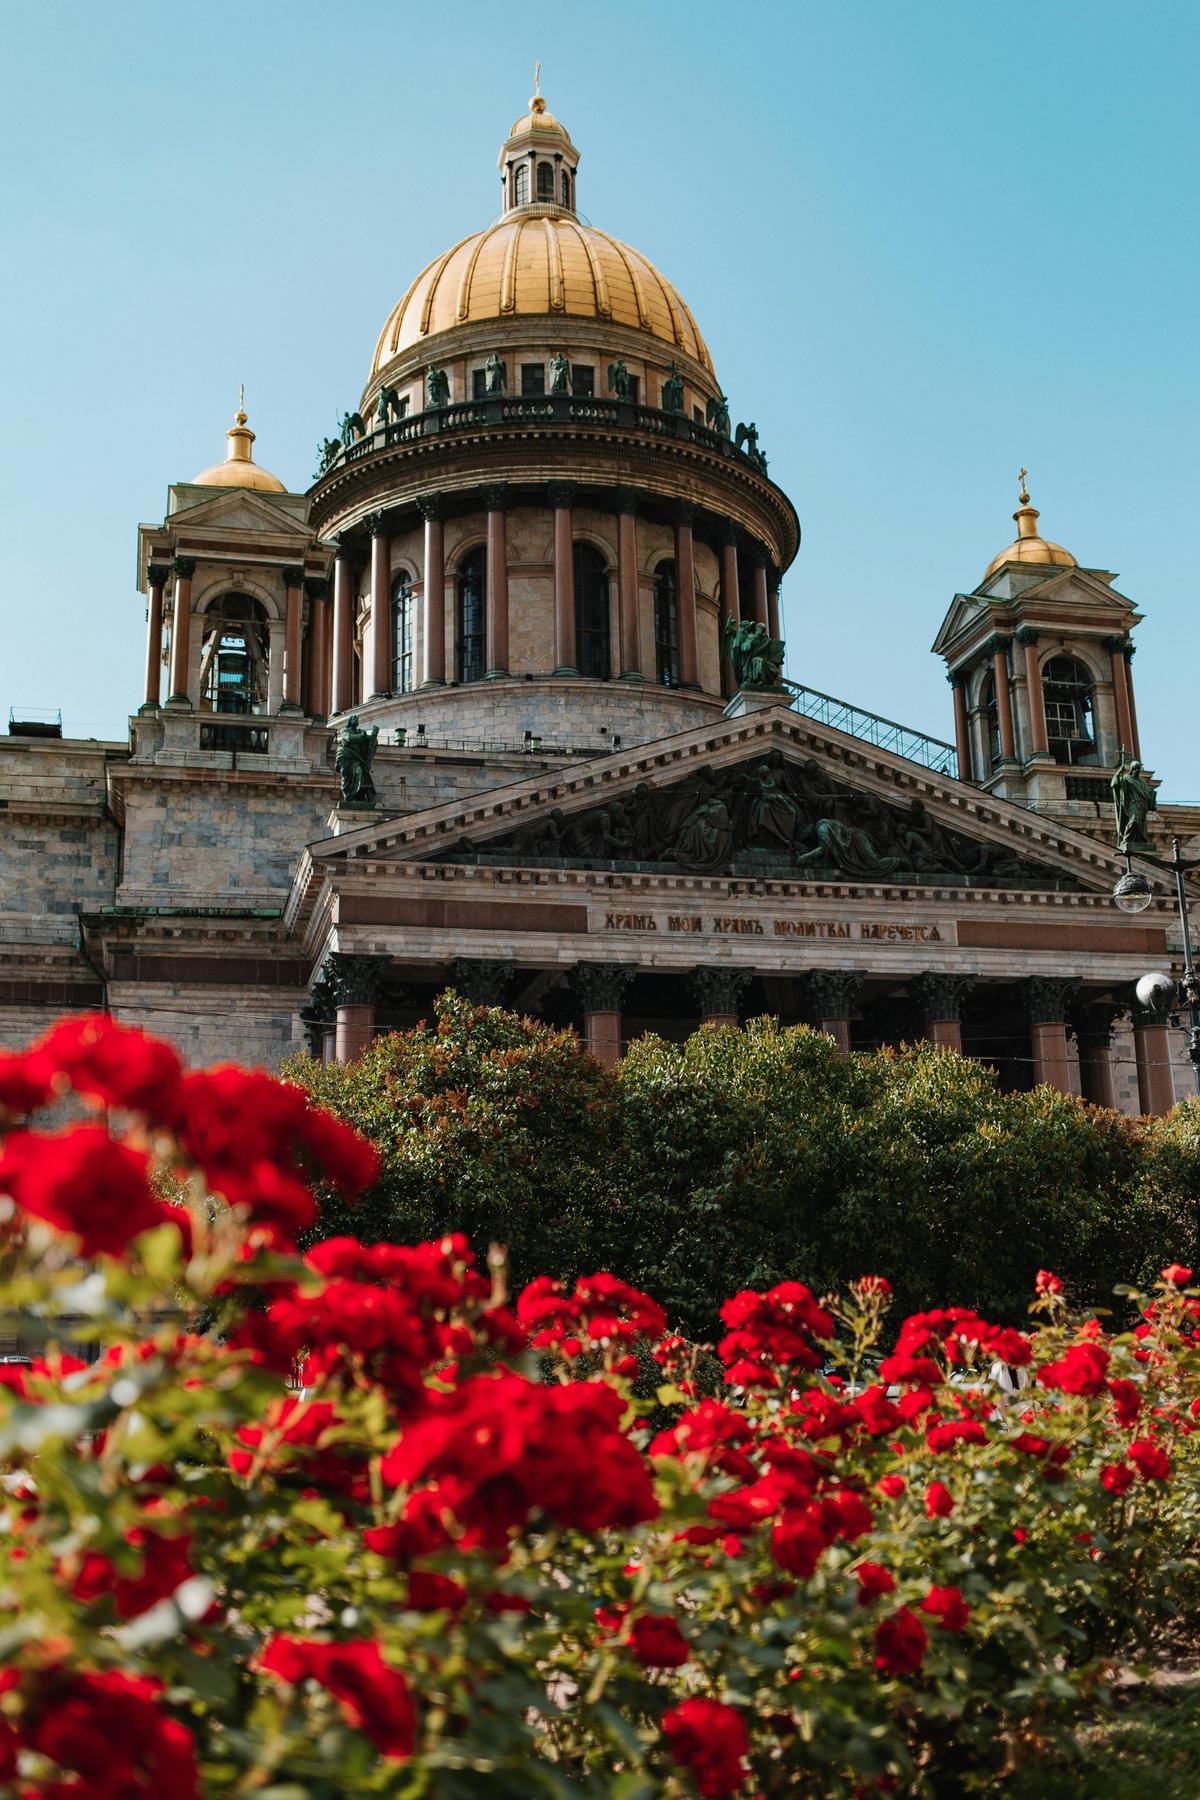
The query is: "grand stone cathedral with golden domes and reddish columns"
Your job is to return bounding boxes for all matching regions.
[0,94,1200,1112]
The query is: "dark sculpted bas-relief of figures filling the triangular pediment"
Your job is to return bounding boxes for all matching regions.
[443,749,1070,887]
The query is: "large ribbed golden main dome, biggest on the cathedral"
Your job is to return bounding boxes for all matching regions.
[371,215,712,374]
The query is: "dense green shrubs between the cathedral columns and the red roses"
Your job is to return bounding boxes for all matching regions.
[290,995,1200,1337]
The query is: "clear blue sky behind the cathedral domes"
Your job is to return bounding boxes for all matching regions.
[0,0,1200,801]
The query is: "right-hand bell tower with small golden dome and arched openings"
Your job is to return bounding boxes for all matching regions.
[934,468,1141,821]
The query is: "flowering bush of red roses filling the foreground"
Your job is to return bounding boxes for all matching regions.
[0,1017,1200,1800]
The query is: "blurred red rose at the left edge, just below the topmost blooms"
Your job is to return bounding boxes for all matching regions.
[0,1125,189,1256]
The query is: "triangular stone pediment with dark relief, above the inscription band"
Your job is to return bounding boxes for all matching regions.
[308,709,1123,893]
